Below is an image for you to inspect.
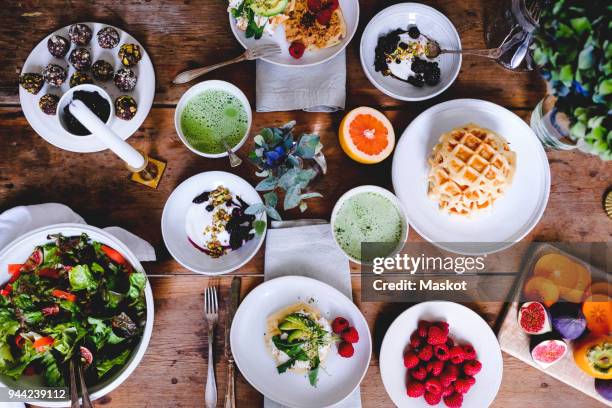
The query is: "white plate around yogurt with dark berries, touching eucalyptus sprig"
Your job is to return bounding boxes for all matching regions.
[161,171,266,275]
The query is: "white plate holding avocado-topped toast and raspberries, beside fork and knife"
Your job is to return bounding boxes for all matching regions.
[230,276,372,408]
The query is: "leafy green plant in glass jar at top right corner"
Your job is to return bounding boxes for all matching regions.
[531,0,612,160]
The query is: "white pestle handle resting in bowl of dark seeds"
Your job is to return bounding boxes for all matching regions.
[68,99,146,170]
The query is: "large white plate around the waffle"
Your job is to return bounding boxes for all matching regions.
[392,99,550,255]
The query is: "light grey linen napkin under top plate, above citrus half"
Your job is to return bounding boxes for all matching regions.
[255,51,346,112]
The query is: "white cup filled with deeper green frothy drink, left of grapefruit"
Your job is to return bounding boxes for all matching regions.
[174,80,252,158]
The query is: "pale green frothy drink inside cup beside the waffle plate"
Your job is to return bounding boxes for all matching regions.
[333,192,403,261]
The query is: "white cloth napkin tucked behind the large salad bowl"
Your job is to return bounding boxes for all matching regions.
[0,203,155,262]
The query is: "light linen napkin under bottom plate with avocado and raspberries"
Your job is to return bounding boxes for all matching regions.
[264,220,361,408]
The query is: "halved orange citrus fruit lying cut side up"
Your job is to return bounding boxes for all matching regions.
[338,106,395,164]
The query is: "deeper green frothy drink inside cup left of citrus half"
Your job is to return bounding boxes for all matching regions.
[180,89,248,154]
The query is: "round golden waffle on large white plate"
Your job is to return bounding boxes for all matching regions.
[428,123,516,216]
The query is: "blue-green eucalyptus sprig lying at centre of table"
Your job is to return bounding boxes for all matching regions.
[245,121,323,220]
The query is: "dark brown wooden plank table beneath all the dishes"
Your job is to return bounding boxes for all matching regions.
[0,0,612,408]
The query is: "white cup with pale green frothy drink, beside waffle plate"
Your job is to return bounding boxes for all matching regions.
[331,186,408,264]
